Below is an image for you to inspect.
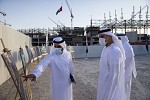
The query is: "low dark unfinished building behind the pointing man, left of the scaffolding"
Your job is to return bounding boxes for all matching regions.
[18,27,86,46]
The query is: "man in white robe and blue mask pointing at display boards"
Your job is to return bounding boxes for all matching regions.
[24,37,75,100]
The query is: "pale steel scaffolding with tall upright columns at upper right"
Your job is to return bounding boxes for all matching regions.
[91,5,150,34]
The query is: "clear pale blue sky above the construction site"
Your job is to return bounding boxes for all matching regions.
[0,0,150,29]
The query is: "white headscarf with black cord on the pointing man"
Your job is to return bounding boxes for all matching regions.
[50,37,67,54]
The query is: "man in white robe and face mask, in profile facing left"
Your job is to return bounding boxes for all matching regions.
[97,28,125,100]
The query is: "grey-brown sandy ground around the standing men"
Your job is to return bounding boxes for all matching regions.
[0,55,150,100]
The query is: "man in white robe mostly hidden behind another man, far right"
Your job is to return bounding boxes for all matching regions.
[117,34,137,100]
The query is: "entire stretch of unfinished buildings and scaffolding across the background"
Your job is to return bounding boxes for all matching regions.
[18,5,150,46]
